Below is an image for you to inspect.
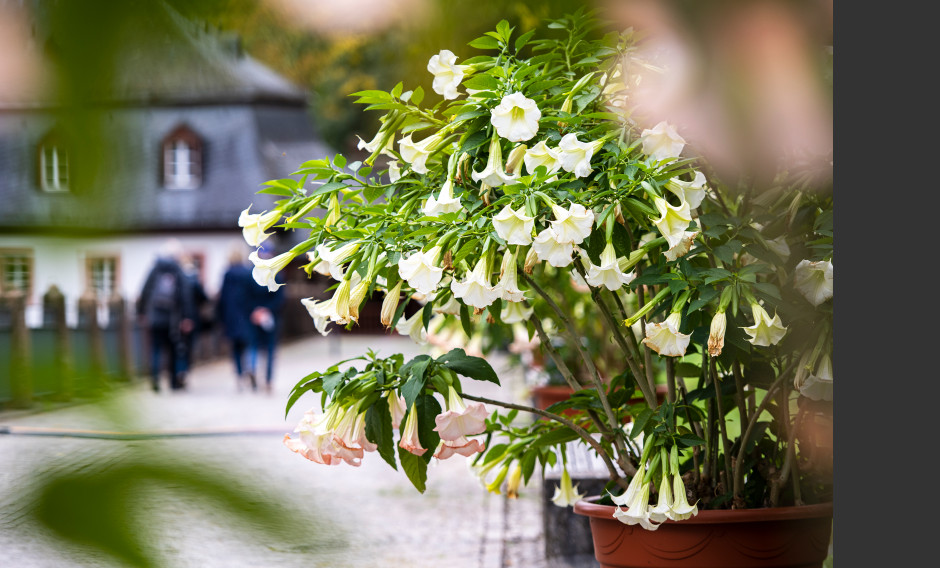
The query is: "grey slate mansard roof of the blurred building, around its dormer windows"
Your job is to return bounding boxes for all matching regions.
[0,1,333,233]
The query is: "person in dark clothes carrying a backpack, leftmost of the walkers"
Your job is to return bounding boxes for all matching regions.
[137,239,193,392]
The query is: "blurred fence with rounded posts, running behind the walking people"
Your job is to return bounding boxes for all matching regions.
[0,279,384,408]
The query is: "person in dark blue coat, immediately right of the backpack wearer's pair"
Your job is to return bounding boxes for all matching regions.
[216,245,259,390]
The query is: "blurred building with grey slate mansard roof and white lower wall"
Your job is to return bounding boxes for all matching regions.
[0,3,334,327]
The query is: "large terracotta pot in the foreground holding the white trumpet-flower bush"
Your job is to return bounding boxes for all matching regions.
[574,497,832,568]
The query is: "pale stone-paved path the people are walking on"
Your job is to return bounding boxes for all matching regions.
[0,332,596,568]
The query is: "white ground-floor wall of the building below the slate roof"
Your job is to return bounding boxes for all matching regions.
[0,230,251,327]
